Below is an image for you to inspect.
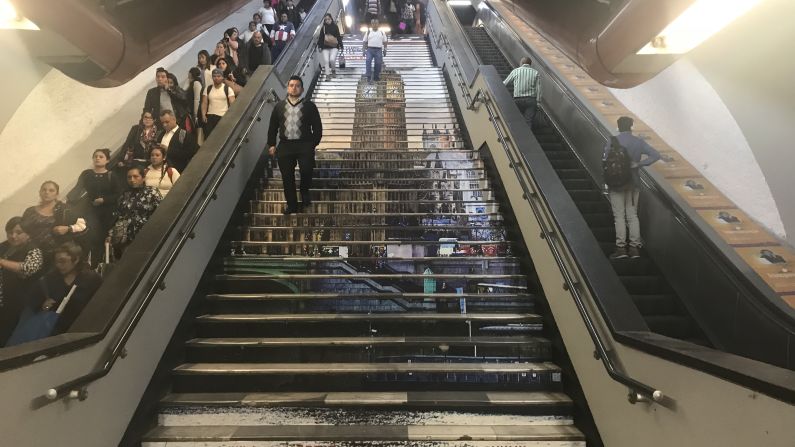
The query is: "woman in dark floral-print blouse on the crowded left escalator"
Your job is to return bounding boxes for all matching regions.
[106,167,163,257]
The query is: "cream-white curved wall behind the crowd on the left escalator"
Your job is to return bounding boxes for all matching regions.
[0,0,261,228]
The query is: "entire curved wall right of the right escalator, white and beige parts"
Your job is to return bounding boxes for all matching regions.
[612,0,795,245]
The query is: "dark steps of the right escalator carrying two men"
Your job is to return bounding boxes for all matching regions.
[464,27,708,345]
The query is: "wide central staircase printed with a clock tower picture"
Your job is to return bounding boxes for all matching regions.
[142,37,585,447]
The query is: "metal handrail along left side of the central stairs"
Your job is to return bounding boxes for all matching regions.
[45,89,279,400]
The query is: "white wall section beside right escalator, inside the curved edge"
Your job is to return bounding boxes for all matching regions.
[611,62,786,242]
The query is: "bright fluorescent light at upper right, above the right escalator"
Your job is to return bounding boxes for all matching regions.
[638,0,762,54]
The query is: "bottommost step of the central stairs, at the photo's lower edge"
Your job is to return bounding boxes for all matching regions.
[143,425,585,447]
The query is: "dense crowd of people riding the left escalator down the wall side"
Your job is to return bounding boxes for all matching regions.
[0,0,324,346]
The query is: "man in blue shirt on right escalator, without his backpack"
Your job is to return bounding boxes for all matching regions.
[604,116,660,259]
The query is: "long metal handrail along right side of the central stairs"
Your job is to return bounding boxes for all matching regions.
[427,14,665,404]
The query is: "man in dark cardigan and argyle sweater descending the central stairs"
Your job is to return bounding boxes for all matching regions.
[268,76,323,214]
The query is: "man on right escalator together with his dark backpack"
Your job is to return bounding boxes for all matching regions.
[602,116,660,259]
